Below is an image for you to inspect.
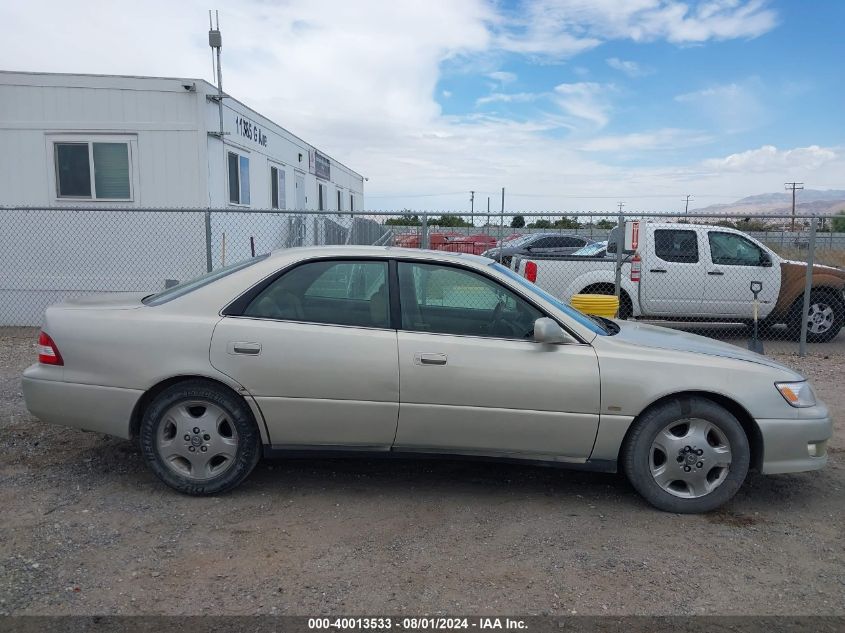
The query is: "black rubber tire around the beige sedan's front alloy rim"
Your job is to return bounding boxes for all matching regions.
[621,397,751,514]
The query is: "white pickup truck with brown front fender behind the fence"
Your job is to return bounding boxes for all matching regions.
[514,222,845,342]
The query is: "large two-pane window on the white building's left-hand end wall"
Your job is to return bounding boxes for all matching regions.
[53,142,132,200]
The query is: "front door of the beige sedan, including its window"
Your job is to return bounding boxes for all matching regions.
[394,261,599,462]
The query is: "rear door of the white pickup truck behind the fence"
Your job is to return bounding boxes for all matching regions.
[640,225,705,316]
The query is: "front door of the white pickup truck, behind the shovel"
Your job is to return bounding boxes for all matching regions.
[704,231,780,319]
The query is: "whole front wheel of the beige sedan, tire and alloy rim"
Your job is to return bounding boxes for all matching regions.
[621,397,750,513]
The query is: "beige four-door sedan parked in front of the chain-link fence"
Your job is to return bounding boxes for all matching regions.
[23,247,831,512]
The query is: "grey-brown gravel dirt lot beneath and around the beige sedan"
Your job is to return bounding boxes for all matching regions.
[0,328,845,615]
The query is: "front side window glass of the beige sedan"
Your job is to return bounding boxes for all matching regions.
[399,262,543,339]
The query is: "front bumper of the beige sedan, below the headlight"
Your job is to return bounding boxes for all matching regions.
[757,417,833,475]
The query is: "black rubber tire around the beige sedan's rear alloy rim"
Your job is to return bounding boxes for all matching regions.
[139,379,261,496]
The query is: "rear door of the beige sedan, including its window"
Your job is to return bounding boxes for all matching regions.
[211,260,399,450]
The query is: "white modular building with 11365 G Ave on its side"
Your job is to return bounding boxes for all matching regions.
[0,71,365,325]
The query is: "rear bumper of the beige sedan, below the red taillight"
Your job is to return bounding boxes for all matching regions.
[21,365,143,439]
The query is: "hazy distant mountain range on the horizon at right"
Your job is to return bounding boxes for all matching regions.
[690,189,845,216]
